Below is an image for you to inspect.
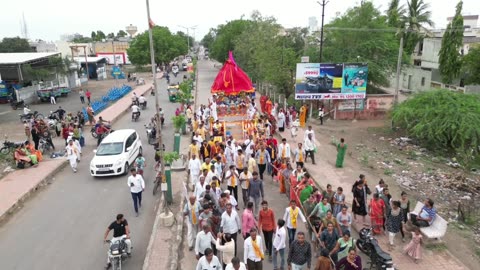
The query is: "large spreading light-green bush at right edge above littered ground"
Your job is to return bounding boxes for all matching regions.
[392,89,480,163]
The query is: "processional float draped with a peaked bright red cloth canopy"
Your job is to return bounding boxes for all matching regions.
[211,52,255,117]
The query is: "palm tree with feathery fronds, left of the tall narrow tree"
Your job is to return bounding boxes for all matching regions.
[403,0,434,55]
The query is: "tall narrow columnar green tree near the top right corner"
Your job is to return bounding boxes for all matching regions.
[439,1,464,84]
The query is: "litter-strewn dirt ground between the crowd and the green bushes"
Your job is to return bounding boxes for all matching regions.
[312,120,480,269]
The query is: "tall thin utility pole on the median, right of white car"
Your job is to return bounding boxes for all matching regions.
[146,0,167,213]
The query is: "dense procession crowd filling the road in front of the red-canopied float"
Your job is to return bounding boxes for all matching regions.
[184,93,435,270]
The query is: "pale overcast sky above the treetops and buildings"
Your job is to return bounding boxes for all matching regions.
[0,0,480,41]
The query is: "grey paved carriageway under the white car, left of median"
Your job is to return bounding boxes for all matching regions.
[0,70,183,270]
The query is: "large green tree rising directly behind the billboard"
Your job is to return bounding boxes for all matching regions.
[323,2,399,88]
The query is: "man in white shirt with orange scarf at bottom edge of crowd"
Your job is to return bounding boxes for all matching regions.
[243,228,265,270]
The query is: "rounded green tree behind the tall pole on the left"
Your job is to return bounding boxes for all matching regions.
[127,26,187,65]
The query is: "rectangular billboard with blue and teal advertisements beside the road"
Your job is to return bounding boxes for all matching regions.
[295,63,368,100]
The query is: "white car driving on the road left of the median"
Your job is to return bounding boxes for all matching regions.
[90,129,142,176]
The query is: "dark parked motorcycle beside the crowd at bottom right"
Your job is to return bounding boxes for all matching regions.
[356,228,395,270]
